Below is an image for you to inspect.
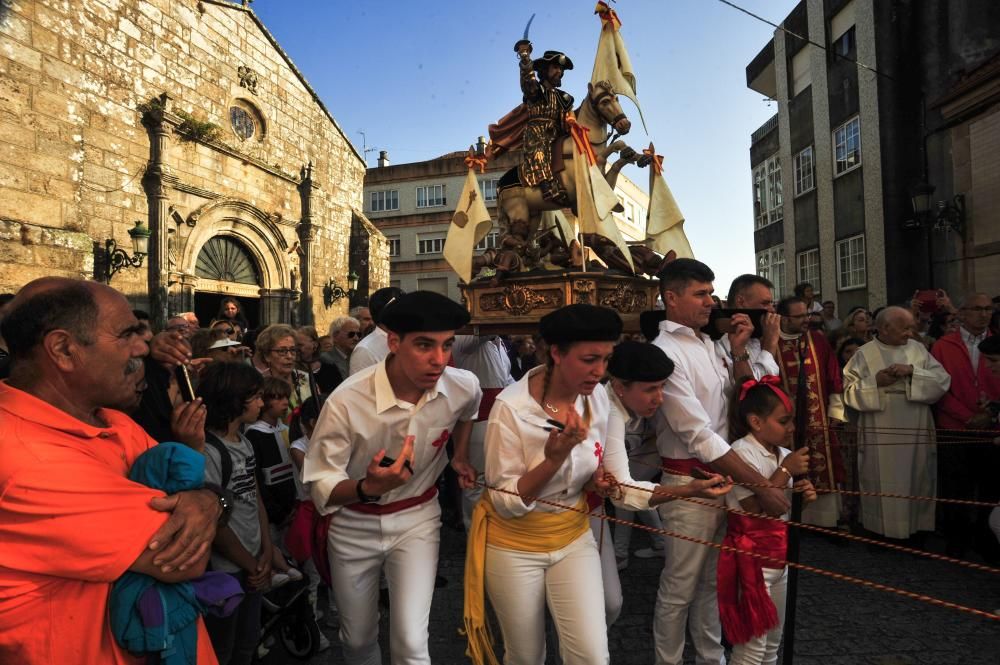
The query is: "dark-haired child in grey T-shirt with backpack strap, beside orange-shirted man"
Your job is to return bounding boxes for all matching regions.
[197,362,272,665]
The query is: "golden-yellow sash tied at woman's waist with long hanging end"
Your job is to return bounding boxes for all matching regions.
[465,491,590,665]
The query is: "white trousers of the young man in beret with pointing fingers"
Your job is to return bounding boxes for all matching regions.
[327,500,441,665]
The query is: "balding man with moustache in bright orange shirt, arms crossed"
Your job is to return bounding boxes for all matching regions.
[0,278,221,665]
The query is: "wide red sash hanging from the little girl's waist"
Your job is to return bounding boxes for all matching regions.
[717,513,788,644]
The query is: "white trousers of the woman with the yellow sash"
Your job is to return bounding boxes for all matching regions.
[486,530,610,665]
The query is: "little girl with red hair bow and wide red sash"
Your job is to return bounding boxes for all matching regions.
[718,376,816,665]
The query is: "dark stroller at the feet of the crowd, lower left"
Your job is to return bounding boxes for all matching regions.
[260,578,320,660]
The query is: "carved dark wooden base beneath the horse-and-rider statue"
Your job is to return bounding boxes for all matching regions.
[459,272,659,335]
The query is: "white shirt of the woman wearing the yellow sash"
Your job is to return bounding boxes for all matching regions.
[484,366,608,518]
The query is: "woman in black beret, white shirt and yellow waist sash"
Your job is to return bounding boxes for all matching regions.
[465,304,721,665]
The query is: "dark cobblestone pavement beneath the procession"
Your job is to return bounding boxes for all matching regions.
[264,527,1000,665]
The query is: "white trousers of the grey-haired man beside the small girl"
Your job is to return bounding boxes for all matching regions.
[653,474,726,665]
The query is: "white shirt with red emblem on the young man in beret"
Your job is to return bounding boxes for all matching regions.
[302,354,482,515]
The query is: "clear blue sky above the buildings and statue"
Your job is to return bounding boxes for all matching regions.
[252,0,796,294]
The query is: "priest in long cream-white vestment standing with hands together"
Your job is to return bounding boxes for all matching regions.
[844,307,951,538]
